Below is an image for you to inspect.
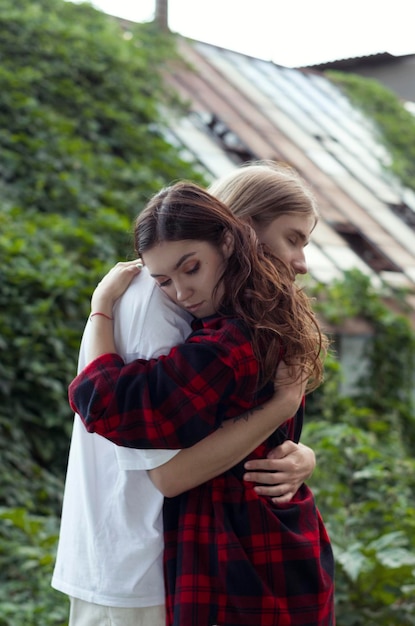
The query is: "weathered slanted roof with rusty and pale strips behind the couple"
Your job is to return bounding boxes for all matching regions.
[168,38,415,316]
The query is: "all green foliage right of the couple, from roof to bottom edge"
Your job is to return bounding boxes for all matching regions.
[303,270,415,626]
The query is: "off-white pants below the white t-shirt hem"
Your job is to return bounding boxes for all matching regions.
[68,598,166,626]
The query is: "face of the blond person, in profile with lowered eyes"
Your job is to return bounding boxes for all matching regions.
[255,213,316,274]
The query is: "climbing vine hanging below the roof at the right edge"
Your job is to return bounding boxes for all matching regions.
[314,270,415,451]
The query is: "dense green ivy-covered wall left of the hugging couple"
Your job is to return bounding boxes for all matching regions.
[0,0,205,626]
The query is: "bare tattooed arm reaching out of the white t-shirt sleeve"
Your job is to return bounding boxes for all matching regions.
[150,364,304,498]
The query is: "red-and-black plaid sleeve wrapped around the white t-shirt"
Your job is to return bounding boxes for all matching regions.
[69,322,258,449]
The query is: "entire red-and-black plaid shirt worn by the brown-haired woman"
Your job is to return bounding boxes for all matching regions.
[69,317,335,626]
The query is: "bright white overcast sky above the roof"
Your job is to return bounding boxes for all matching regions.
[76,0,415,67]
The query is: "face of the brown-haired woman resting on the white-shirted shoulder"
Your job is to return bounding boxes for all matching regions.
[142,239,230,318]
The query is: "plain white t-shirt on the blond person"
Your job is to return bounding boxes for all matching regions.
[52,268,190,607]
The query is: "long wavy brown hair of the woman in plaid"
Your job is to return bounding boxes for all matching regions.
[134,182,327,391]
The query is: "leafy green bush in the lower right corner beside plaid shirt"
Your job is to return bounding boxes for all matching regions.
[304,420,415,626]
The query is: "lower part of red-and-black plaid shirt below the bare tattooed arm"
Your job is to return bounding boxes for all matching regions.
[164,436,335,626]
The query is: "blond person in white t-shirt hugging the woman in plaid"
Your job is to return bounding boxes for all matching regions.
[52,162,317,626]
